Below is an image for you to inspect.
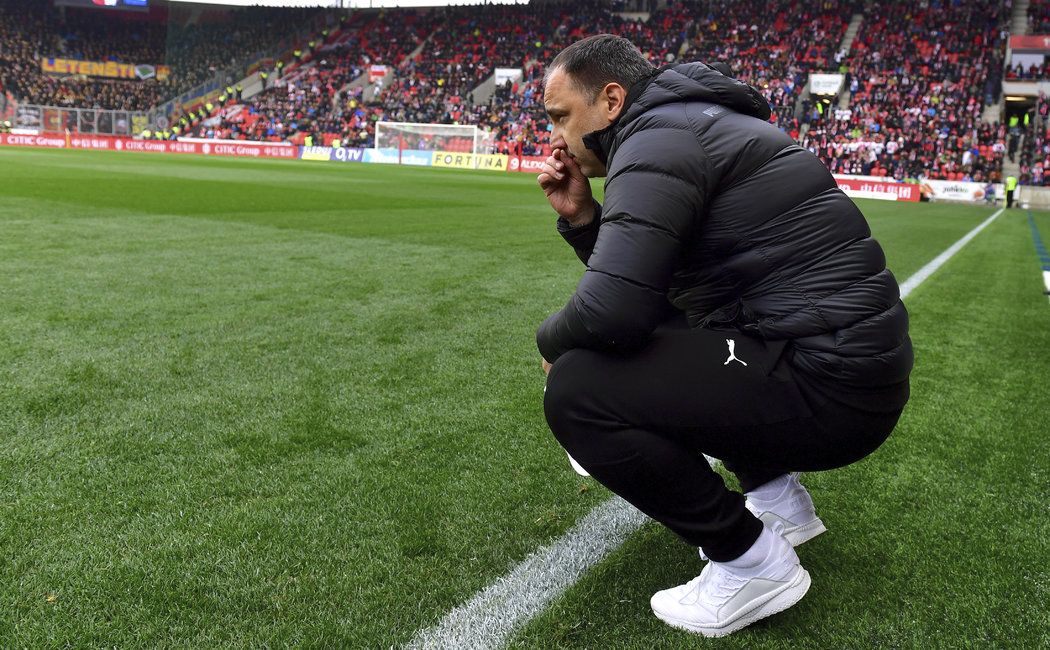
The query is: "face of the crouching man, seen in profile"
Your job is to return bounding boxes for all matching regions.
[543,67,626,179]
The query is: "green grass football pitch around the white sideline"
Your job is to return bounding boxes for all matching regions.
[0,149,1050,649]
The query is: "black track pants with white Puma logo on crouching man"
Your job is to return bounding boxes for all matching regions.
[544,328,900,562]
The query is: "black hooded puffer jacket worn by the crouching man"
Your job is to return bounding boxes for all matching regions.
[537,63,912,403]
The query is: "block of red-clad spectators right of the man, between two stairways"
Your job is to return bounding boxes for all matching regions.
[802,0,1006,182]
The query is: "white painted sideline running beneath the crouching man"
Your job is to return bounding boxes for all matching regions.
[405,208,999,650]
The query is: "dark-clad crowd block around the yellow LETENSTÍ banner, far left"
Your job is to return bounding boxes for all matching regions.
[0,0,326,111]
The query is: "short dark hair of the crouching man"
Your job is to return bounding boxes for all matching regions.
[544,34,655,102]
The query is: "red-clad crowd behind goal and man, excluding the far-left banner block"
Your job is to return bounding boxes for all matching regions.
[174,0,1006,185]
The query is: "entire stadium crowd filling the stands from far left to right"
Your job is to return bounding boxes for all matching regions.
[0,0,1033,185]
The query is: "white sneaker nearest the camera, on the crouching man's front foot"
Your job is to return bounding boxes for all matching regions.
[650,534,810,636]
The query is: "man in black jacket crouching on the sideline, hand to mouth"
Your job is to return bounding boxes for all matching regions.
[537,35,912,636]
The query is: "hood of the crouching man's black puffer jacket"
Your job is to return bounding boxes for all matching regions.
[583,63,770,165]
